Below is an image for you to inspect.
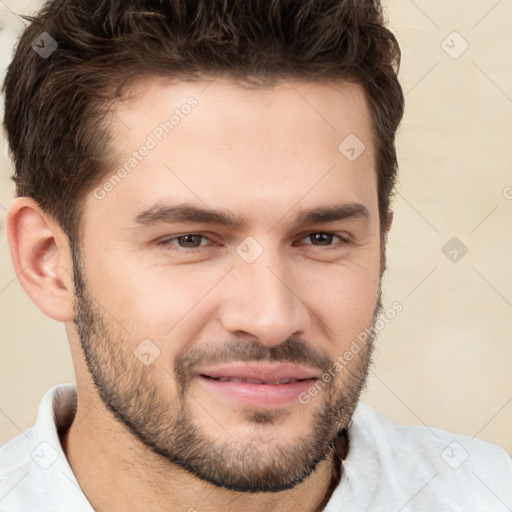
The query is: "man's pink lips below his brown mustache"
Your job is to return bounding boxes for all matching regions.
[196,363,318,408]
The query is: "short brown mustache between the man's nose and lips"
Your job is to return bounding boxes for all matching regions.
[174,337,335,384]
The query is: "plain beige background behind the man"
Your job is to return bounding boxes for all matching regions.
[0,0,512,453]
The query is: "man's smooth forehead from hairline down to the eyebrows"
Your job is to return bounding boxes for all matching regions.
[86,77,377,230]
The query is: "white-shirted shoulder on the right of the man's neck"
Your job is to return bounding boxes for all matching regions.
[336,403,512,512]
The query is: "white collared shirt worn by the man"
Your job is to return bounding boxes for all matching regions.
[0,384,512,512]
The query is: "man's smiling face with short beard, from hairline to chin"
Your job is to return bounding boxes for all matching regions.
[74,79,382,492]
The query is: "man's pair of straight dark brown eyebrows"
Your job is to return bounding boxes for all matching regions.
[130,203,370,229]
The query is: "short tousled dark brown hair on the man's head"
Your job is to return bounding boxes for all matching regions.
[3,0,404,240]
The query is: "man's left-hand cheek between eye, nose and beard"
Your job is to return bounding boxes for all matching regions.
[87,256,222,356]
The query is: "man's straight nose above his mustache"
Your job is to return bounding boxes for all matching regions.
[221,250,311,347]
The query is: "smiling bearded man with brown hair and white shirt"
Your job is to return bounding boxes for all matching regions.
[0,0,512,512]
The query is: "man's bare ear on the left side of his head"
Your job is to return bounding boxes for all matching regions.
[7,197,74,322]
